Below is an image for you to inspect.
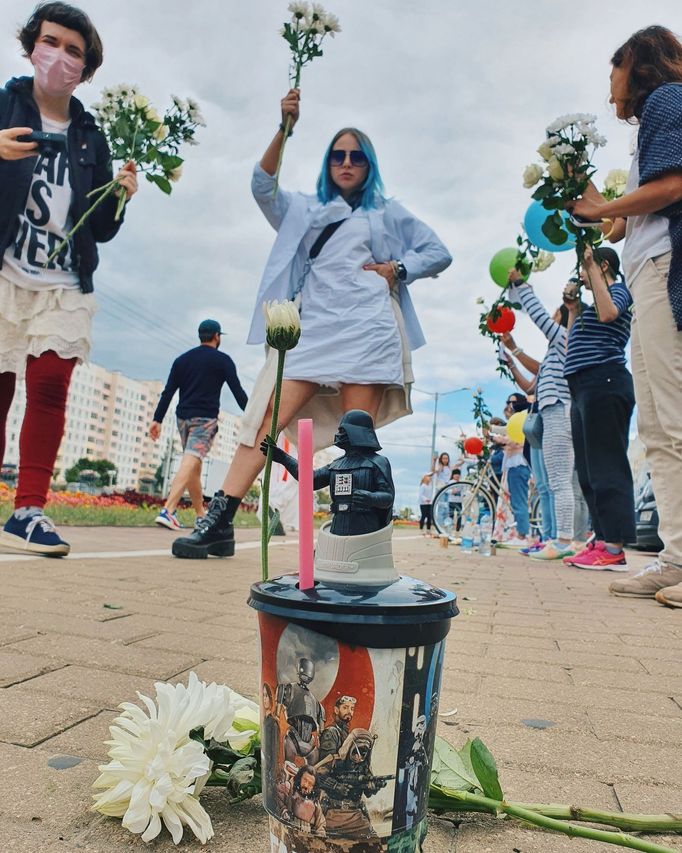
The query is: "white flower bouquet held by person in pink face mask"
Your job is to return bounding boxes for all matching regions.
[48,85,206,261]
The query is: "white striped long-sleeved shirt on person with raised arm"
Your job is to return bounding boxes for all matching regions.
[509,284,571,411]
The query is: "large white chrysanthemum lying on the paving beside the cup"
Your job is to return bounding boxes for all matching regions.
[93,672,248,844]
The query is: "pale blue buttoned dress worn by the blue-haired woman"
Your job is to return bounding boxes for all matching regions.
[284,204,404,388]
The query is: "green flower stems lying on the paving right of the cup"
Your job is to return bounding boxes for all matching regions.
[429,786,681,853]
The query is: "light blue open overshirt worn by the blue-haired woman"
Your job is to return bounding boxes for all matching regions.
[247,163,452,350]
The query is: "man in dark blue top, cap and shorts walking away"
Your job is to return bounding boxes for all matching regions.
[149,320,248,530]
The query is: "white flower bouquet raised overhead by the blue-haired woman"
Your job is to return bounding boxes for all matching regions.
[274,0,341,193]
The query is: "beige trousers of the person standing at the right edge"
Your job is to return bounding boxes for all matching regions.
[628,252,682,567]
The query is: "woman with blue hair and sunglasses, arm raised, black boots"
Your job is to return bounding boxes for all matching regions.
[173,89,452,558]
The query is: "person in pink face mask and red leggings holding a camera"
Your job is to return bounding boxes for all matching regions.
[0,2,137,557]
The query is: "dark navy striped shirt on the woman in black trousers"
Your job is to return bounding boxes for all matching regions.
[564,281,632,376]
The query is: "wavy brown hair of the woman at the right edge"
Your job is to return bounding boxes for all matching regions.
[611,26,682,122]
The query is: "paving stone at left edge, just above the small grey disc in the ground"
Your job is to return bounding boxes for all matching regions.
[0,684,98,746]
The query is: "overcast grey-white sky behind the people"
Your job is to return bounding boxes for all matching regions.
[0,0,680,506]
